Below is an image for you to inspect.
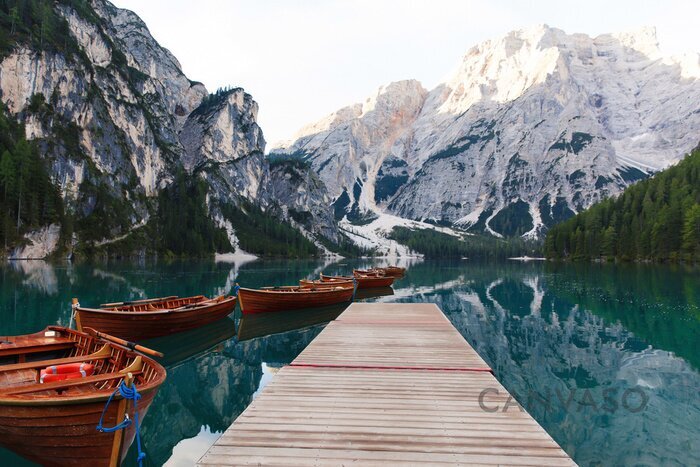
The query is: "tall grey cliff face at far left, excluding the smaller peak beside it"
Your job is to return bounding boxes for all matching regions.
[0,1,207,240]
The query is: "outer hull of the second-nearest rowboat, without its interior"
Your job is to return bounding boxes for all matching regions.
[76,298,236,341]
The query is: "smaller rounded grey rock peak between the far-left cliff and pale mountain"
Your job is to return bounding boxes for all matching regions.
[180,88,338,241]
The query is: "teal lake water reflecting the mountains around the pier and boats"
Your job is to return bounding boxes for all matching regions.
[0,261,700,466]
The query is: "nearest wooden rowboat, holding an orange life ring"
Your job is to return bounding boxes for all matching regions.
[0,326,166,466]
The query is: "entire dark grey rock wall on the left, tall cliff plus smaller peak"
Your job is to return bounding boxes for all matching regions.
[0,0,336,256]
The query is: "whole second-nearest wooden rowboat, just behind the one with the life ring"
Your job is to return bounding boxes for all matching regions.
[75,295,236,341]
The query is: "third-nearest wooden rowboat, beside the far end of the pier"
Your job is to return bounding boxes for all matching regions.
[238,284,355,314]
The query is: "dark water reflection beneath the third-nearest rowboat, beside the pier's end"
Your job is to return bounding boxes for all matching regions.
[238,303,349,341]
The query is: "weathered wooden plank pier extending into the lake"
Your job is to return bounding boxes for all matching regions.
[199,303,575,466]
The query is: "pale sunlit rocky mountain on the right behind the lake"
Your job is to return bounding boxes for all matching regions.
[272,26,700,236]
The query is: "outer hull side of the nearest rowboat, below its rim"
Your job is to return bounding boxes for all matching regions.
[0,387,158,466]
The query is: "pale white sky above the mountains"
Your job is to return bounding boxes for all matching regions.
[113,0,700,150]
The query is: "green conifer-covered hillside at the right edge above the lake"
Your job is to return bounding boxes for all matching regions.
[545,148,700,262]
